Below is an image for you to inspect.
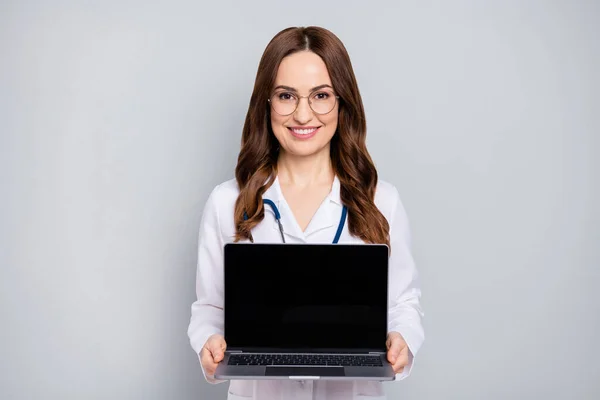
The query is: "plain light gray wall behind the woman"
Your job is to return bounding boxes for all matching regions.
[0,0,600,399]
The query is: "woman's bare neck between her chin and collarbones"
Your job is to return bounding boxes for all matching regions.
[277,149,334,186]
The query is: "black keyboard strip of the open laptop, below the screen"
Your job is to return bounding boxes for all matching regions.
[228,354,382,367]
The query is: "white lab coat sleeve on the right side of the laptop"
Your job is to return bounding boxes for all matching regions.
[388,188,425,380]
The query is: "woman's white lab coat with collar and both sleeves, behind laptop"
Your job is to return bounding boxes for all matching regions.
[188,177,424,400]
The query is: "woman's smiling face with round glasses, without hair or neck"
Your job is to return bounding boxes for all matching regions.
[270,51,339,156]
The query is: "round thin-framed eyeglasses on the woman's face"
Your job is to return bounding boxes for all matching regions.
[268,89,340,116]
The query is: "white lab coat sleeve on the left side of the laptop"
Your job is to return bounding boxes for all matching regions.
[188,186,224,383]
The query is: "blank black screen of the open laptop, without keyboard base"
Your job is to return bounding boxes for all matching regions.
[224,244,388,352]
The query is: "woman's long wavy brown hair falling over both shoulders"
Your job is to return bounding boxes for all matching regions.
[235,26,390,246]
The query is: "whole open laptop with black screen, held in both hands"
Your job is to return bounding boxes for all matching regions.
[215,243,395,381]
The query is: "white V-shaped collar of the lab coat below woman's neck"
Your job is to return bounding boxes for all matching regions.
[263,175,342,241]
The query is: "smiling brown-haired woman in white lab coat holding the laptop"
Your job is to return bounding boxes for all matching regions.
[188,27,424,399]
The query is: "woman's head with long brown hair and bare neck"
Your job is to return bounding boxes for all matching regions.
[235,27,390,245]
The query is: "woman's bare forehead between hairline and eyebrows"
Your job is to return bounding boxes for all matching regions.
[275,51,331,90]
